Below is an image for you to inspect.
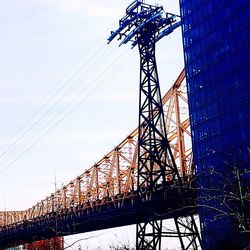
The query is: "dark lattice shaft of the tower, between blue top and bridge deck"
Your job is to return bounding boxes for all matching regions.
[137,24,181,201]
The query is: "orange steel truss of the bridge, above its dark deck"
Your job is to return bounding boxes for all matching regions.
[0,70,193,227]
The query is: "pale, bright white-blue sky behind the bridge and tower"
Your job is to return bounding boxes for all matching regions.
[0,0,183,249]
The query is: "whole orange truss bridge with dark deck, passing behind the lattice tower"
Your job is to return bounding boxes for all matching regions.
[0,70,199,247]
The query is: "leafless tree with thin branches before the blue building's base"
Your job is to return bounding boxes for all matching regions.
[190,150,250,249]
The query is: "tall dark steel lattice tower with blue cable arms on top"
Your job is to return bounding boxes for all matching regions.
[108,1,197,249]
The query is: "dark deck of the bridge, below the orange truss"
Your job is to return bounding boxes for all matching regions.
[0,188,196,249]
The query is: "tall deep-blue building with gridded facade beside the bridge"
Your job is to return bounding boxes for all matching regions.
[180,0,250,250]
